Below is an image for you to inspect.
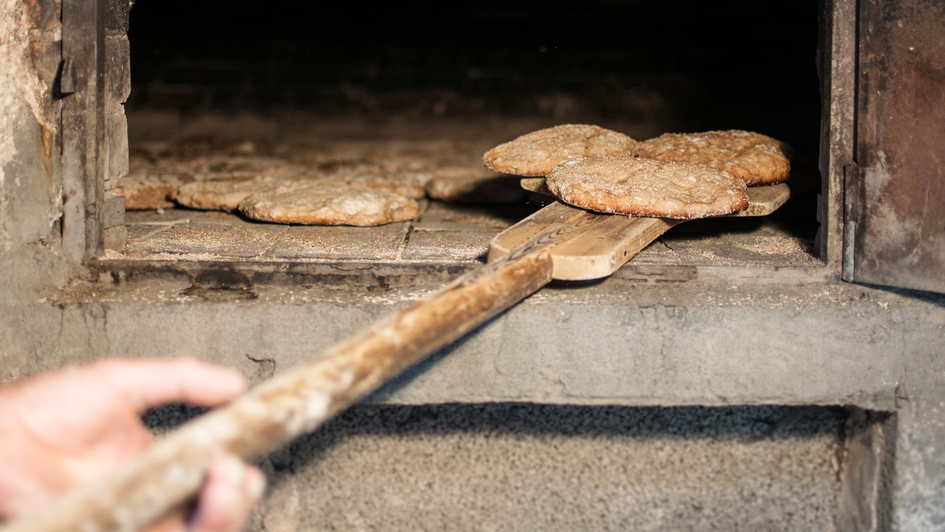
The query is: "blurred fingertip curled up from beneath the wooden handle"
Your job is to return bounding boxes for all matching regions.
[188,455,266,532]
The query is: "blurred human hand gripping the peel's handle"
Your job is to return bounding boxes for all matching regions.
[0,358,265,532]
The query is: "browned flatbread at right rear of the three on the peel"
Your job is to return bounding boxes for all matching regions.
[635,129,791,186]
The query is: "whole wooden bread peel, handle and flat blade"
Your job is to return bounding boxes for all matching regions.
[4,181,788,532]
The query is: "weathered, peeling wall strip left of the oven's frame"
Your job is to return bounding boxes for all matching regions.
[0,0,69,380]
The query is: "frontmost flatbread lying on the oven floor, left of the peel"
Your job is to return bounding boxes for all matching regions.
[239,184,420,226]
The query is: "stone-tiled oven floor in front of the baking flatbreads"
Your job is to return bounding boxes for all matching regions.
[114,201,817,266]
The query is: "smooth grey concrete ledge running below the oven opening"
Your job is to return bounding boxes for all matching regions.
[23,265,945,410]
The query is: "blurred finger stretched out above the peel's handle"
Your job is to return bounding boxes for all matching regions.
[84,357,246,412]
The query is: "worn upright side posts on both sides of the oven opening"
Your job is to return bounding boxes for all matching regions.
[62,0,856,278]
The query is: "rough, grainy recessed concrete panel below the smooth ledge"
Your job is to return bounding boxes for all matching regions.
[149,403,845,532]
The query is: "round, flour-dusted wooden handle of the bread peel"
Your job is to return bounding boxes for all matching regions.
[6,229,573,532]
